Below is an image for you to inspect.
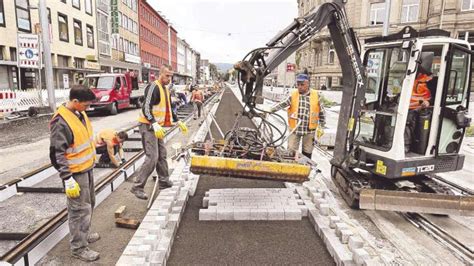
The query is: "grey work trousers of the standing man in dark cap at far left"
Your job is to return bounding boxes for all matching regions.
[67,170,95,253]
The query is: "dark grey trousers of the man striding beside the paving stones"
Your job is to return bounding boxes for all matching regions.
[133,123,169,191]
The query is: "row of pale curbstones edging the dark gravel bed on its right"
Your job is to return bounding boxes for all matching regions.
[286,183,380,265]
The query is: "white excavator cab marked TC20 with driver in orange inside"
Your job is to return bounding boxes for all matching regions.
[354,27,471,179]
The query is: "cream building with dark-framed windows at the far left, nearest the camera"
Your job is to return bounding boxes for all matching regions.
[0,0,100,89]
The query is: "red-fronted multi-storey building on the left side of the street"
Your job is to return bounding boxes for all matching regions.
[139,0,170,82]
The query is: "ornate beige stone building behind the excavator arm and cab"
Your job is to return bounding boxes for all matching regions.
[296,0,474,88]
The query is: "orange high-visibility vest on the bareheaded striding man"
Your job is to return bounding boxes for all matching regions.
[138,80,171,127]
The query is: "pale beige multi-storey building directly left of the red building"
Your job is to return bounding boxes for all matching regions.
[109,0,141,77]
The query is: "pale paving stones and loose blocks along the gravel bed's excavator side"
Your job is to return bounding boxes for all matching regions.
[285,175,393,265]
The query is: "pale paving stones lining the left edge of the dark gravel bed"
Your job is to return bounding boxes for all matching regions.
[116,91,222,266]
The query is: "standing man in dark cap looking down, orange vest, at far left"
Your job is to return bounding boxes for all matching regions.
[49,85,100,261]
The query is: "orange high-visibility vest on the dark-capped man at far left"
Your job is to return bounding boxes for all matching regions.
[53,105,95,173]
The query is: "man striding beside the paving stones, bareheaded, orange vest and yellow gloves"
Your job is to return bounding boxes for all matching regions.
[131,65,188,200]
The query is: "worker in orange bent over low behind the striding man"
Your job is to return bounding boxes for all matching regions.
[95,128,128,167]
